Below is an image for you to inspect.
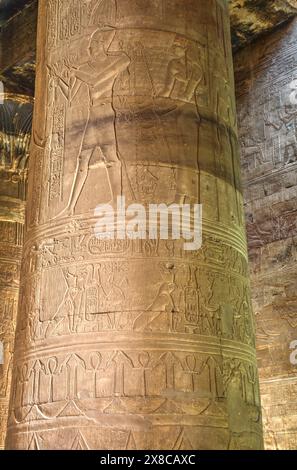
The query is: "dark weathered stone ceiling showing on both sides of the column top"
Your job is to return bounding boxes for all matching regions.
[0,0,297,95]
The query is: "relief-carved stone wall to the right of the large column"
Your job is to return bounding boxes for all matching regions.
[235,20,297,449]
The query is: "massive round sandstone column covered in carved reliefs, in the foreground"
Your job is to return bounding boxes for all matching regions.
[7,0,262,450]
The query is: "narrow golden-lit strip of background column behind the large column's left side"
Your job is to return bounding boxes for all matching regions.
[0,95,33,449]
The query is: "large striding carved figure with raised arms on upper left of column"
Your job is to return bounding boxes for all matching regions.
[52,28,130,217]
